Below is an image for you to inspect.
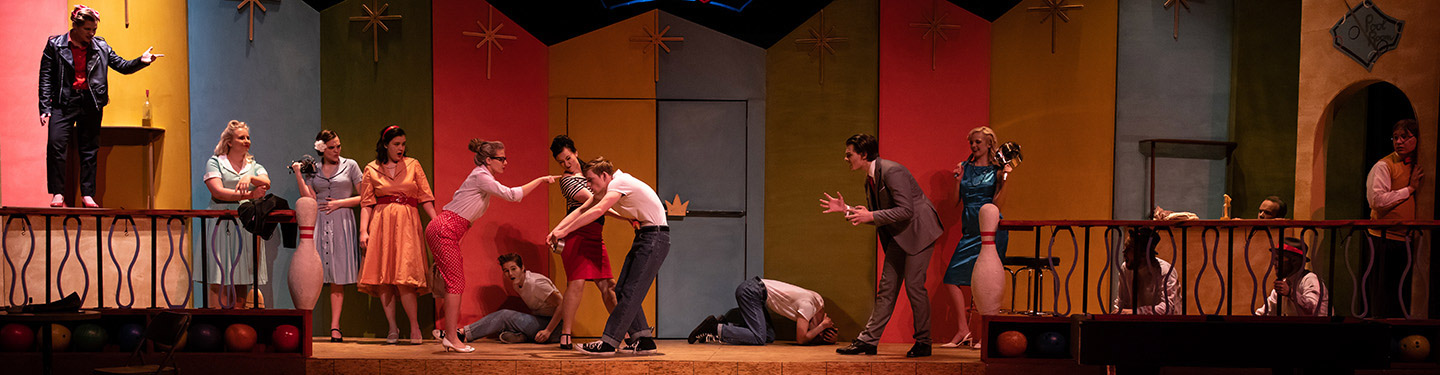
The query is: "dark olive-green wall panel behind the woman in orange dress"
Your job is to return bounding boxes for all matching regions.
[316,0,439,336]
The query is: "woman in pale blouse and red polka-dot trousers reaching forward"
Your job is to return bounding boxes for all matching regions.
[425,138,557,353]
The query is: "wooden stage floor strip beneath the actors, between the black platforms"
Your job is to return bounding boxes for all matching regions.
[307,339,985,375]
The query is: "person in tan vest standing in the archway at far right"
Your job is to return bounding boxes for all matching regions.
[1361,118,1426,317]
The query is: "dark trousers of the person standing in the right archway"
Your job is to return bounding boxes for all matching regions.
[1361,237,1418,317]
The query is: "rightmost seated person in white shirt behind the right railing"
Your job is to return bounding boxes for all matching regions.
[1256,237,1331,316]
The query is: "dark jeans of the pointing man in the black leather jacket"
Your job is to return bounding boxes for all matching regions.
[45,91,104,196]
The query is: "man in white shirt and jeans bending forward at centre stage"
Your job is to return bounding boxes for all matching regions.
[546,157,670,355]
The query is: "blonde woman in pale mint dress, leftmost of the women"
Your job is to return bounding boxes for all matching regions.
[194,120,271,309]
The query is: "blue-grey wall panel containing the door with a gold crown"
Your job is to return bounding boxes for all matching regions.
[651,13,765,338]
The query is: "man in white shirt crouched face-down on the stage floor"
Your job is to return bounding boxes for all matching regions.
[688,277,838,345]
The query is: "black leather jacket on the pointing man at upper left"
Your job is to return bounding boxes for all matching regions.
[40,33,150,115]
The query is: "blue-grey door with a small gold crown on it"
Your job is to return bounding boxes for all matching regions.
[655,100,750,338]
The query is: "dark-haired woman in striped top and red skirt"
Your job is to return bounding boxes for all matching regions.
[536,134,615,350]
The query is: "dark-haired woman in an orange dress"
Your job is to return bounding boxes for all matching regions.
[359,125,435,345]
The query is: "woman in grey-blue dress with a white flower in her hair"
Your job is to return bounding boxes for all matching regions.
[289,130,360,342]
